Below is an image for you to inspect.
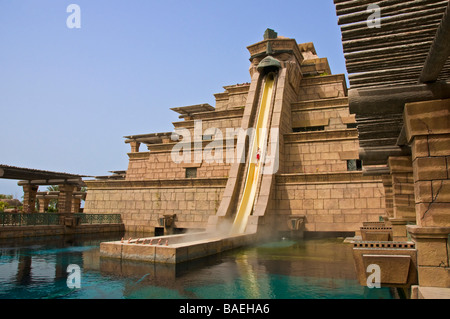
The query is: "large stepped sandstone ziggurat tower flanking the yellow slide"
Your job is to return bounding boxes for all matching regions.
[84,29,385,240]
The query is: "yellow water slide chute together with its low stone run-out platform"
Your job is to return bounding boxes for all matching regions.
[100,73,276,266]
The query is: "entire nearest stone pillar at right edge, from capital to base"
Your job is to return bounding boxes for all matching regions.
[403,100,450,288]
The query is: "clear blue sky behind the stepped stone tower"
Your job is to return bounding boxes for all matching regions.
[0,0,346,198]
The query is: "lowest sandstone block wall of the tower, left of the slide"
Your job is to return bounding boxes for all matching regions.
[84,182,224,232]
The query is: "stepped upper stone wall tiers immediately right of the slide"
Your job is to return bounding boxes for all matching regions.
[285,75,359,173]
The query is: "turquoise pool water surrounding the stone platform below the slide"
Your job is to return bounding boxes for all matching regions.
[0,235,393,299]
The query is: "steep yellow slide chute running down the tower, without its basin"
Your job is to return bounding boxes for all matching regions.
[231,73,275,234]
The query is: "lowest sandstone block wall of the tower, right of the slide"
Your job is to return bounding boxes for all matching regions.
[274,173,385,232]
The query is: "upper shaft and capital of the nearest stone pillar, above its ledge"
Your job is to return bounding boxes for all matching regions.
[404,100,450,227]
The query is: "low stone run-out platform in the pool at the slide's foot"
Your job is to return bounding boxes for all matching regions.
[100,232,257,264]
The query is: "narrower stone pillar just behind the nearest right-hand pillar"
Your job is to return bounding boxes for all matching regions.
[389,156,416,241]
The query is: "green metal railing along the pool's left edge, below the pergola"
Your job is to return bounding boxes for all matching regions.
[0,212,122,227]
